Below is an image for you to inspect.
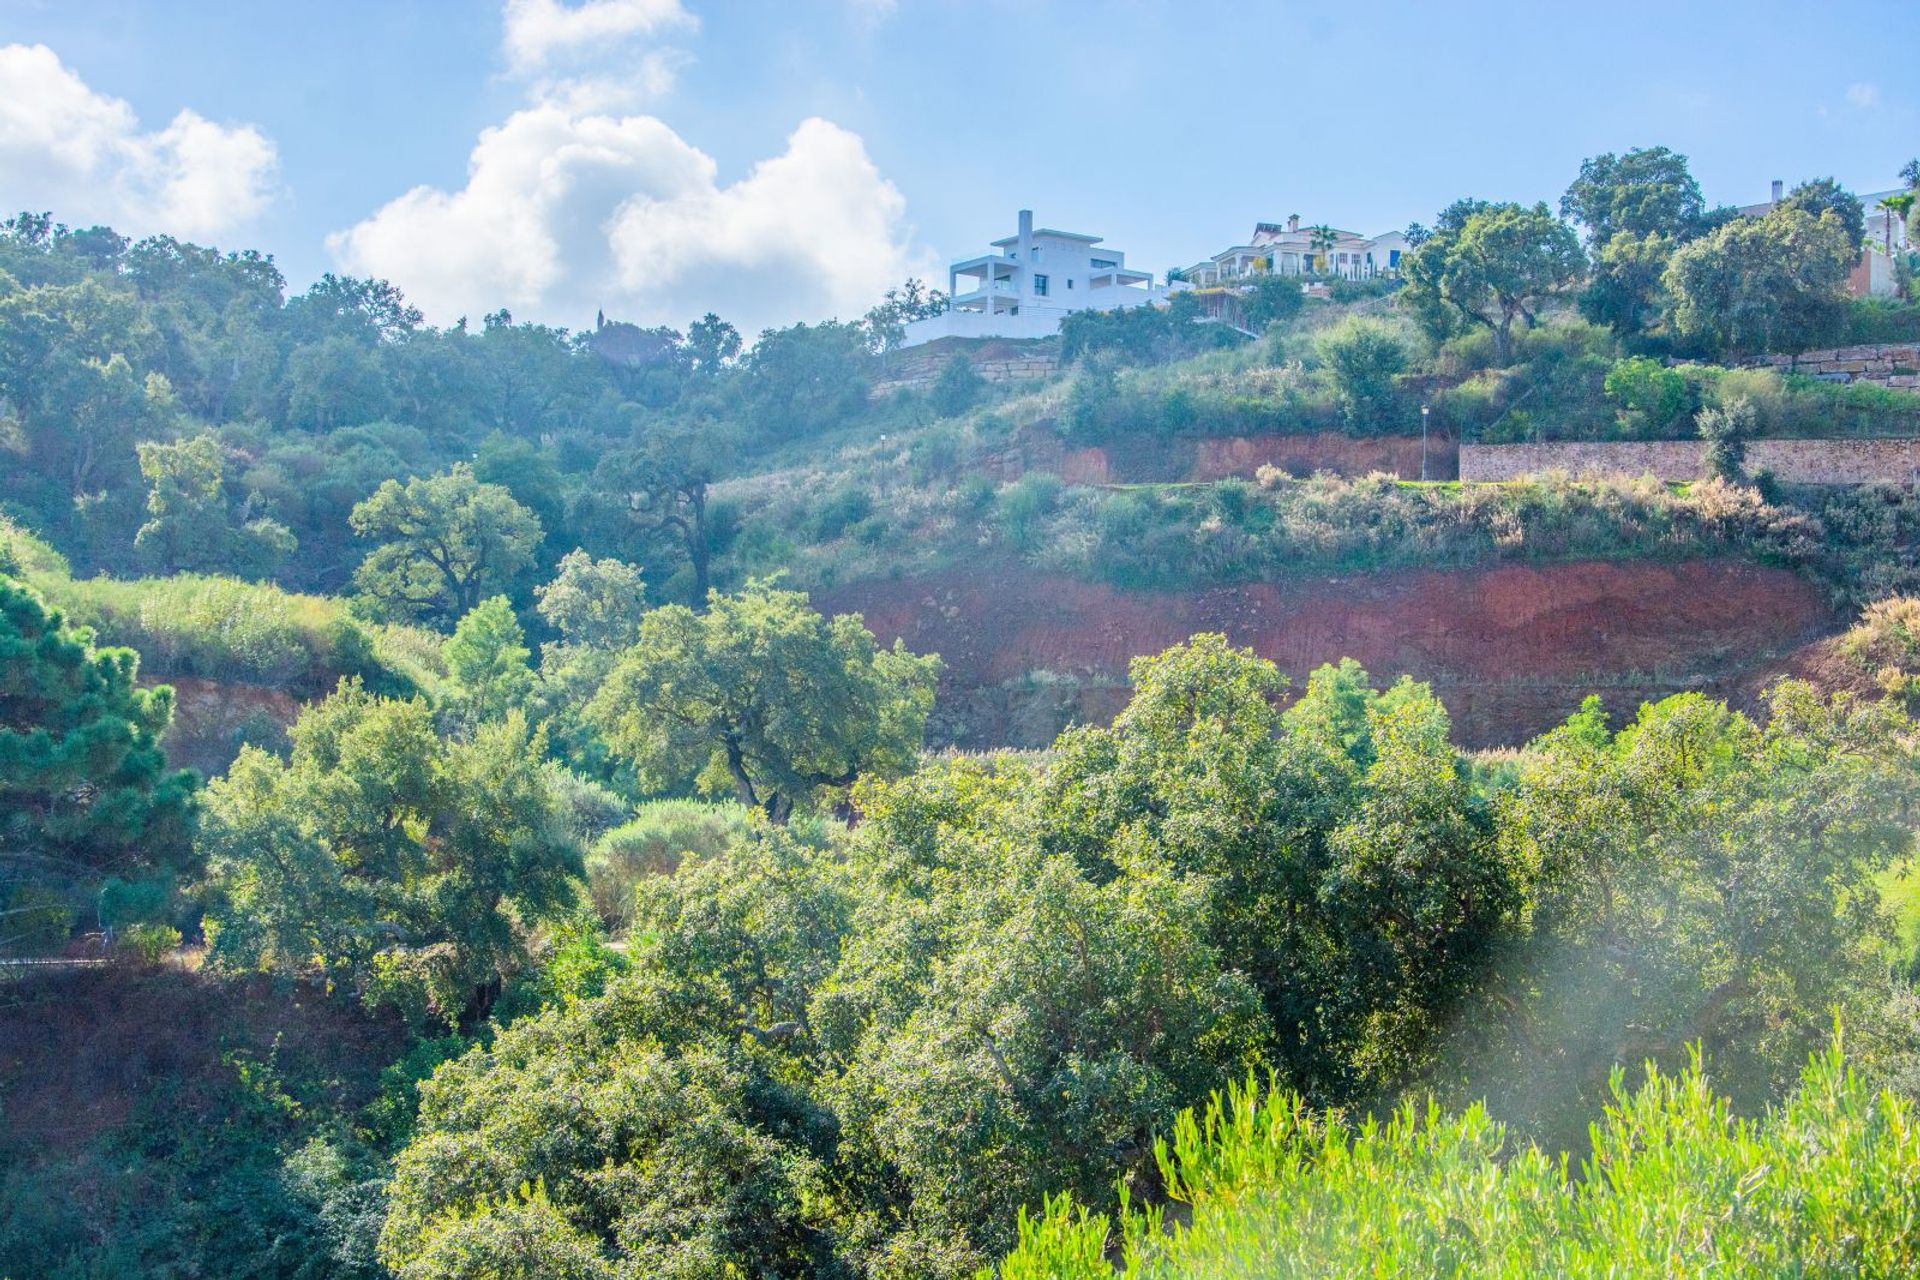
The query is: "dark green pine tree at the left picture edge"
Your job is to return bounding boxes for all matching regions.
[0,576,196,936]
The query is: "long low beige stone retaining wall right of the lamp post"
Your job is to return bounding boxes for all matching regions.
[1459,438,1920,484]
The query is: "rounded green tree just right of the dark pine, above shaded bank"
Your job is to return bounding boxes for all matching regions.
[204,683,580,1023]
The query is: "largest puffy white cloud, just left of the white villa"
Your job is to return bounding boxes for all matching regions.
[326,104,929,334]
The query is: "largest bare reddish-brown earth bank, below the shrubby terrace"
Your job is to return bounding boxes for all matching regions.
[814,560,1837,747]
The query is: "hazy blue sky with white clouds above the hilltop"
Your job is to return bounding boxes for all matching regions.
[0,0,1920,332]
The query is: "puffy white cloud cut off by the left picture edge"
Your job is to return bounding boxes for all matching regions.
[0,44,278,238]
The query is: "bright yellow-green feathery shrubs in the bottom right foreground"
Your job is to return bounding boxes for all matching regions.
[983,1036,1920,1280]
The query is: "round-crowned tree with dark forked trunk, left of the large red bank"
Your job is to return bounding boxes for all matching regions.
[589,583,939,821]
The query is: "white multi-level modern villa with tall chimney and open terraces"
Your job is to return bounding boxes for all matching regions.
[904,209,1167,347]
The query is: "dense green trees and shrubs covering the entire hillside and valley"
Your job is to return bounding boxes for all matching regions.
[11,150,1920,1280]
